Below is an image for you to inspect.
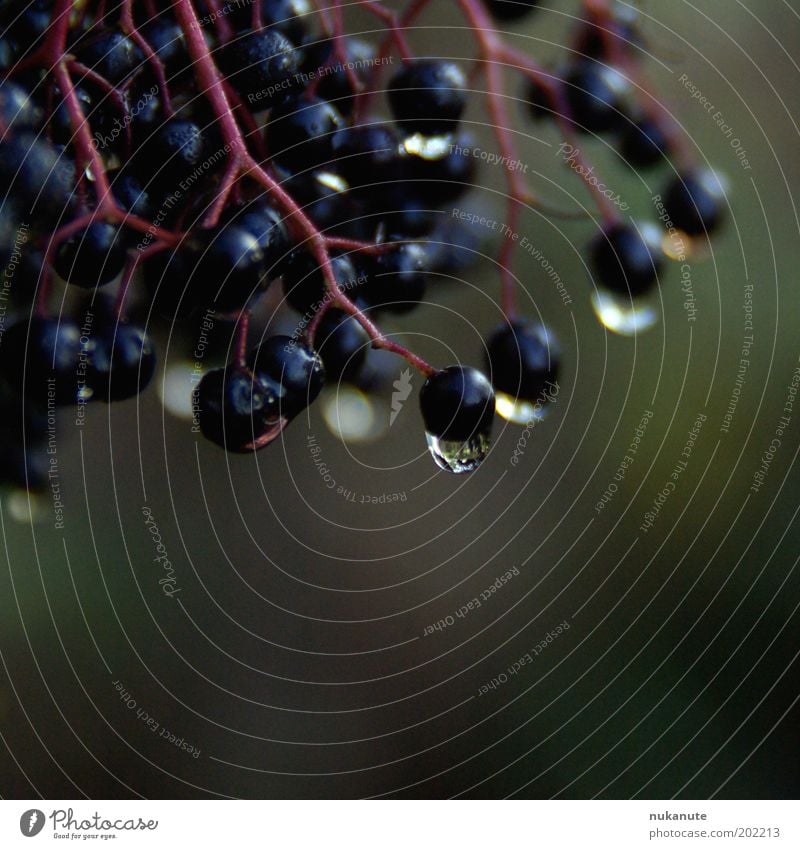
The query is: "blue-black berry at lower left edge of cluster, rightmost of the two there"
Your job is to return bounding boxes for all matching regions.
[87,324,156,401]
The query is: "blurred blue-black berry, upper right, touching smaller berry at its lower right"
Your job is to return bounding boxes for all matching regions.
[564,62,627,133]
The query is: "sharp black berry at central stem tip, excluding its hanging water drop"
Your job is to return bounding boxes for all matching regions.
[419,366,495,442]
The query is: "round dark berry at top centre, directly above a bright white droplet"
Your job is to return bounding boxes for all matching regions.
[389,60,467,136]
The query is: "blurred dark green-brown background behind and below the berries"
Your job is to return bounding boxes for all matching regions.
[0,0,800,798]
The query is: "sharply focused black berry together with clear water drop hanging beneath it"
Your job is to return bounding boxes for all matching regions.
[419,366,495,474]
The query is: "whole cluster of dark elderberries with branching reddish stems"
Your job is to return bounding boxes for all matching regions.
[0,0,722,488]
